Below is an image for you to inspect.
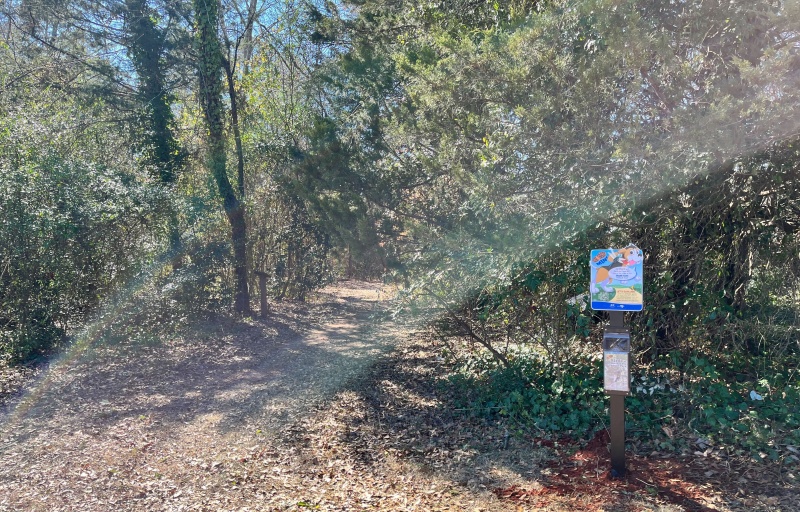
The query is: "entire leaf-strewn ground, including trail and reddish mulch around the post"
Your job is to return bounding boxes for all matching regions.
[0,282,800,512]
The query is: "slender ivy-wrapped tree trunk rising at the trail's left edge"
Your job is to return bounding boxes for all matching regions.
[193,0,250,313]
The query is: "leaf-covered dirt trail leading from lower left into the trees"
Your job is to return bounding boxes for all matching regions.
[0,282,510,511]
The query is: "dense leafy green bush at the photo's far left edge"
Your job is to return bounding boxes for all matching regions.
[0,130,164,360]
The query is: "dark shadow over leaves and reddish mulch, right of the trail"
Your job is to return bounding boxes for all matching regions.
[272,328,797,512]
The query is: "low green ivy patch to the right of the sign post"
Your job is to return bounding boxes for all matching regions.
[627,352,800,462]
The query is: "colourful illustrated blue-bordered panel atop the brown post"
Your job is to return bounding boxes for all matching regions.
[589,245,644,311]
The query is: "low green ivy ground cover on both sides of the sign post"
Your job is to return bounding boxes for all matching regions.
[440,338,800,464]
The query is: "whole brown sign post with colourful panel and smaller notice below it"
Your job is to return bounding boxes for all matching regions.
[590,245,644,478]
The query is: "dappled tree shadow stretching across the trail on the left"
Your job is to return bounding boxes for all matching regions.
[4,280,389,443]
